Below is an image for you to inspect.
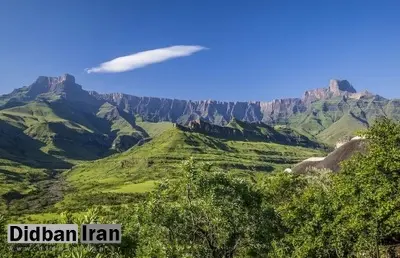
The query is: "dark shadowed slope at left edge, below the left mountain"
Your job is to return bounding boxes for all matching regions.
[0,120,72,169]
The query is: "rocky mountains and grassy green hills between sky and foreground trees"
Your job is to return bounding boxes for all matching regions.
[0,74,400,215]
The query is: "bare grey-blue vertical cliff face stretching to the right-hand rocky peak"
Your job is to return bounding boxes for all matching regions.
[91,80,370,125]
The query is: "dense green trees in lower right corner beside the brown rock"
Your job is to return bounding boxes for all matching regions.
[267,119,400,257]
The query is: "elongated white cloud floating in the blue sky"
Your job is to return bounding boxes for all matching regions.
[85,46,206,73]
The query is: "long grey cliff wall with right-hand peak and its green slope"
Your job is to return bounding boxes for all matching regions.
[90,77,400,144]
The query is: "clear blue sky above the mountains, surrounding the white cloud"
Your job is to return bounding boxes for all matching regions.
[0,0,400,101]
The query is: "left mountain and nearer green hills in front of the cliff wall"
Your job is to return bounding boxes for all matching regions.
[0,75,328,215]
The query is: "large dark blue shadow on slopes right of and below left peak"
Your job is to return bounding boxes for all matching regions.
[48,100,149,157]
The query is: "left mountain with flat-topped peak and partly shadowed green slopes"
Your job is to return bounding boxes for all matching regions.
[0,74,148,167]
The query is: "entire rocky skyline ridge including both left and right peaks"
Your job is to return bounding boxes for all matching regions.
[0,74,400,144]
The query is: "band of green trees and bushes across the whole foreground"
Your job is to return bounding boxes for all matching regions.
[0,119,400,257]
